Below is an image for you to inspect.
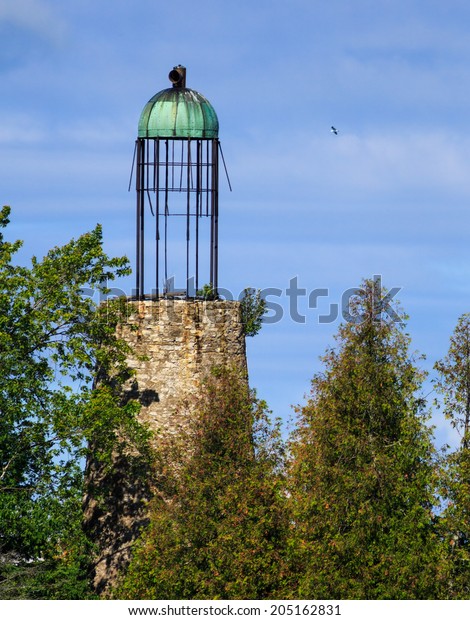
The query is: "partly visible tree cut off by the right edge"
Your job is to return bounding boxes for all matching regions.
[435,314,470,599]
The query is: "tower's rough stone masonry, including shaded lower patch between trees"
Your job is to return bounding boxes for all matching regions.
[84,299,247,593]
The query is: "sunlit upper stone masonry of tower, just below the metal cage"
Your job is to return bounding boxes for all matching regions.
[120,299,246,434]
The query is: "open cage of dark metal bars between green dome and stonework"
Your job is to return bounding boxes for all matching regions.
[134,137,219,299]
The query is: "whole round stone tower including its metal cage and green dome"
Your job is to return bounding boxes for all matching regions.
[84,66,247,592]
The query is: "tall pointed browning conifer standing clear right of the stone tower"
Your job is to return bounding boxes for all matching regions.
[288,280,442,599]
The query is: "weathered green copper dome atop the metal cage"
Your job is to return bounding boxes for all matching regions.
[138,86,219,139]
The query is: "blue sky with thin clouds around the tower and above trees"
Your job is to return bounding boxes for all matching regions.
[0,0,470,443]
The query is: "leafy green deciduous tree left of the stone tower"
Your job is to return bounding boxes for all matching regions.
[0,207,144,598]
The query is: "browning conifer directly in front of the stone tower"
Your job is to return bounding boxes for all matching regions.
[116,369,288,599]
